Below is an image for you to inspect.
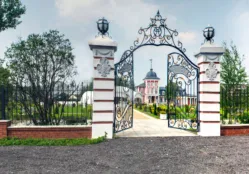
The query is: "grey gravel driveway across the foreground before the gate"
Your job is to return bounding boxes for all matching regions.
[0,136,249,174]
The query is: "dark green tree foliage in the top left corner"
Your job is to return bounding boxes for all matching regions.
[0,0,26,32]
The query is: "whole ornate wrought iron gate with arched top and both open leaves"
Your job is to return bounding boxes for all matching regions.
[113,11,199,133]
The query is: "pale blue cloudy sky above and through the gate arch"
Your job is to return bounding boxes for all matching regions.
[0,0,249,86]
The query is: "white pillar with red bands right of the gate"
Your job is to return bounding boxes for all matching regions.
[195,42,224,136]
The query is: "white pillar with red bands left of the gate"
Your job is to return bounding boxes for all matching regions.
[89,36,117,138]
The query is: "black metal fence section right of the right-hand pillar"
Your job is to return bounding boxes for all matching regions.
[220,84,249,124]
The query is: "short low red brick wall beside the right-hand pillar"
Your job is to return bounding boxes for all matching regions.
[220,124,249,136]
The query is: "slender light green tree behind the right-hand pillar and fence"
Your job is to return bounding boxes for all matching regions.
[220,42,248,123]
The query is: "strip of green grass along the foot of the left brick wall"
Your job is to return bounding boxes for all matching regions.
[0,136,106,146]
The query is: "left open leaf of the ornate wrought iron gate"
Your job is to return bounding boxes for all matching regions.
[114,51,135,132]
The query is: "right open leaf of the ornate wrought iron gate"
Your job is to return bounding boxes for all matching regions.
[167,53,199,130]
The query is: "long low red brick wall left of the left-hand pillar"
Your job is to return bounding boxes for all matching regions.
[0,121,92,139]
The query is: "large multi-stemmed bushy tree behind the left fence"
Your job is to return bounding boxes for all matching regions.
[5,30,77,124]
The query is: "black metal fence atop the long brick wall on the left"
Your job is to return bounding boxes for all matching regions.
[0,82,93,126]
